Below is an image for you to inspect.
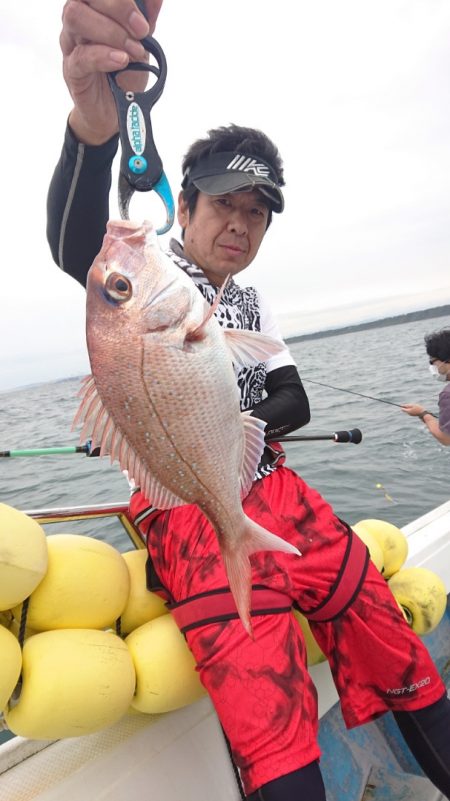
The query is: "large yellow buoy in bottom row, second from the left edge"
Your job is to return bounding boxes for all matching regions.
[5,629,136,740]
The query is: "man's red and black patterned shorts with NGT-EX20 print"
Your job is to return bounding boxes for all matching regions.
[130,467,445,794]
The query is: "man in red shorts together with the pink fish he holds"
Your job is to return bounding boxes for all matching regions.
[48,0,450,801]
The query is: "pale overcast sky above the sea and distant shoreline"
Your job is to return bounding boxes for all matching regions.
[0,0,450,389]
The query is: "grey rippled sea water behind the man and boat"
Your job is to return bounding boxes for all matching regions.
[0,317,450,550]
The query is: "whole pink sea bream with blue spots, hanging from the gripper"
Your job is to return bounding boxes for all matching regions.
[74,221,299,633]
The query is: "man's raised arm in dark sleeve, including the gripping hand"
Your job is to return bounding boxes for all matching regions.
[47,0,162,285]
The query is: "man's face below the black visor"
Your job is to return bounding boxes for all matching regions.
[178,190,269,286]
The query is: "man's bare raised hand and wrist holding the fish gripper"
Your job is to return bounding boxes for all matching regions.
[60,0,163,145]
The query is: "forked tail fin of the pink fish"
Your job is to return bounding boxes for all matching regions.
[222,517,301,638]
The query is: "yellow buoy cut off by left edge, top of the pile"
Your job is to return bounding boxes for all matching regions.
[0,503,47,610]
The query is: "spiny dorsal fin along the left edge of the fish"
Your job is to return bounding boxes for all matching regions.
[72,376,186,509]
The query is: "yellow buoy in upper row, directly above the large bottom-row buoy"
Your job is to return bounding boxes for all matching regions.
[13,534,130,631]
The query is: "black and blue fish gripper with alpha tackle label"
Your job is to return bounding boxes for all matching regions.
[108,29,175,234]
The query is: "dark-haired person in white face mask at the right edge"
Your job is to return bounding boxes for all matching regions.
[402,328,450,445]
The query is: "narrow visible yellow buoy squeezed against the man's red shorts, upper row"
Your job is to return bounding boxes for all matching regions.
[115,548,167,634]
